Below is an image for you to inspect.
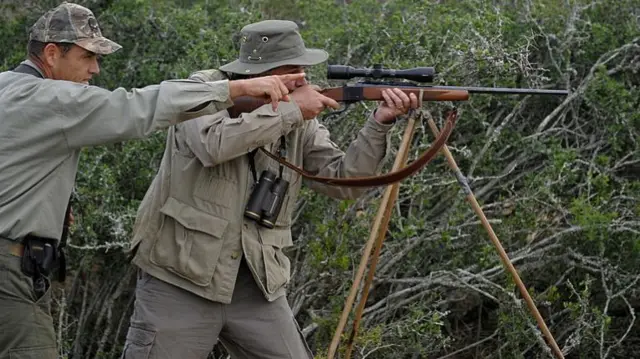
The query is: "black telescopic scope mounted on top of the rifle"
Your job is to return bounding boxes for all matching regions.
[327,65,436,82]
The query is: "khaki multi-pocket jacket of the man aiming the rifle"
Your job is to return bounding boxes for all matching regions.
[132,70,393,303]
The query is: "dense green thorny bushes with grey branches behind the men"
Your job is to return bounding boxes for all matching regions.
[0,0,640,359]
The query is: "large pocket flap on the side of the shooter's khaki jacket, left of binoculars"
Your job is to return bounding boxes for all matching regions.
[160,197,229,238]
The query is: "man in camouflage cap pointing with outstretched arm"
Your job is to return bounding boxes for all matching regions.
[0,2,304,359]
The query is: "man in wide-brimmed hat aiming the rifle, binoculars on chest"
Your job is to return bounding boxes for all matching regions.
[122,20,418,359]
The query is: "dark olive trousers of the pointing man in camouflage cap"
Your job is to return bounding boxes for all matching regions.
[0,238,57,359]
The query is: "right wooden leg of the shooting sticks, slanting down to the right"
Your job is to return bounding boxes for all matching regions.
[428,115,564,359]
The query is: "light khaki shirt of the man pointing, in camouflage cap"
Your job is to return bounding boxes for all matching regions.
[0,60,233,240]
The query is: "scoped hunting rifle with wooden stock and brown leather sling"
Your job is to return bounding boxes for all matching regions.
[227,64,569,187]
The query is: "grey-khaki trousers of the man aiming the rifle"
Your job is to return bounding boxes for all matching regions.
[121,261,313,359]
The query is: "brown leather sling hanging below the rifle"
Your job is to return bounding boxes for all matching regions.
[260,109,457,187]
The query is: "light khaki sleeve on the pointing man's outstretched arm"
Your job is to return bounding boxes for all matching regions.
[45,80,233,148]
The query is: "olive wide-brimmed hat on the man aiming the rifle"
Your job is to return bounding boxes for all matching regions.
[220,20,329,75]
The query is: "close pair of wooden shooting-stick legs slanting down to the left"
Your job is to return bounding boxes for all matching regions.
[328,97,422,359]
